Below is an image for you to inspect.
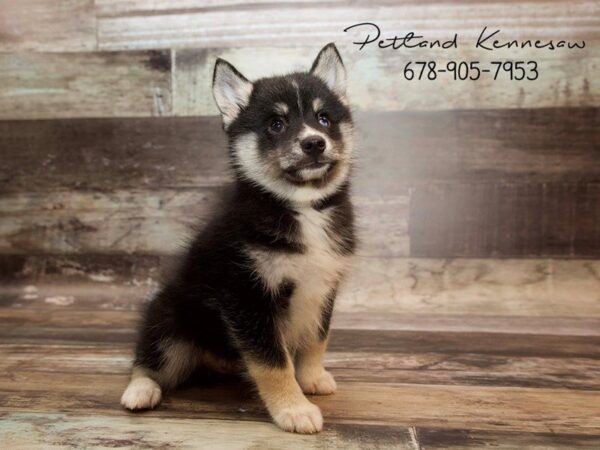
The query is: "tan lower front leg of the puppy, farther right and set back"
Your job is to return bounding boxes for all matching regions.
[296,341,337,395]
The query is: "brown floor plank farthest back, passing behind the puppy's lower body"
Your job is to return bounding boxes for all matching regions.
[0,305,600,359]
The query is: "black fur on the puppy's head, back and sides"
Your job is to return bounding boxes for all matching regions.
[135,47,355,388]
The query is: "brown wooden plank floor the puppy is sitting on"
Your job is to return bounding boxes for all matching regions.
[0,268,600,450]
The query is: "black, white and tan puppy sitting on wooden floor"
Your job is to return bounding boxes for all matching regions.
[121,44,355,433]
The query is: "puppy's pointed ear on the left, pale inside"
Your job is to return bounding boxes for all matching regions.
[213,58,252,129]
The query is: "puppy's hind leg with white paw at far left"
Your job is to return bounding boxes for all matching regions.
[121,339,199,410]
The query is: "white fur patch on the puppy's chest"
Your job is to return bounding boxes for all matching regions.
[249,208,349,349]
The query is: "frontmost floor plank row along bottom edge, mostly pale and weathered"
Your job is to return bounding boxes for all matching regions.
[0,412,600,450]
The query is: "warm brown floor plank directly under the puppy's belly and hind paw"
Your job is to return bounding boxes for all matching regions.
[0,373,600,435]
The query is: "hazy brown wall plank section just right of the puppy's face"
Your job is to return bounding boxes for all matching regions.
[357,108,600,193]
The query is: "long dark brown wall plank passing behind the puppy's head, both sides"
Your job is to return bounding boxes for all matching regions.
[5,108,600,196]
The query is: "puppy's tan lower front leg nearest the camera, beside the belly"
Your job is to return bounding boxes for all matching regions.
[248,361,323,433]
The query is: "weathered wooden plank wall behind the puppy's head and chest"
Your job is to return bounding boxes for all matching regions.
[0,0,600,258]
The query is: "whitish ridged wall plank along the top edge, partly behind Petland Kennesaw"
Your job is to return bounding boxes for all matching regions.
[97,0,600,50]
